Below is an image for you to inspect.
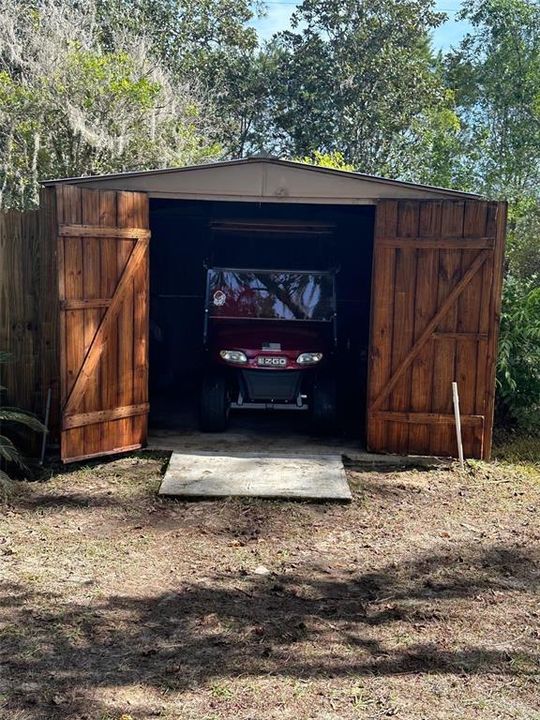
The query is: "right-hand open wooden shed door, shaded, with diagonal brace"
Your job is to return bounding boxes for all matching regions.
[367,200,506,458]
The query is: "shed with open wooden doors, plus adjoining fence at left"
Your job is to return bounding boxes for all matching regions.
[0,158,506,462]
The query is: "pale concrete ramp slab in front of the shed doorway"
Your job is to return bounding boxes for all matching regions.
[159,452,352,501]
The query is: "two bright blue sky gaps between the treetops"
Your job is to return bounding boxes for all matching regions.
[255,0,468,50]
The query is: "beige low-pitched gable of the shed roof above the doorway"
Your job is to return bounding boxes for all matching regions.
[43,157,480,205]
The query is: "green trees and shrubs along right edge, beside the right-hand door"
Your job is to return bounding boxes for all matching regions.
[445,0,540,431]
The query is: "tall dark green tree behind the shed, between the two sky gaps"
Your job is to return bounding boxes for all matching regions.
[255,0,445,176]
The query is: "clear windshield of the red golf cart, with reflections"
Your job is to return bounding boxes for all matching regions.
[206,268,335,322]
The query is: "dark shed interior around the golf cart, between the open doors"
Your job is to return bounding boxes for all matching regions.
[150,199,375,440]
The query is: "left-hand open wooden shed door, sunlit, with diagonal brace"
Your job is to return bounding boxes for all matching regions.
[56,185,150,462]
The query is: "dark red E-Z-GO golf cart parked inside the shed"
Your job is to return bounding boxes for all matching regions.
[200,267,336,432]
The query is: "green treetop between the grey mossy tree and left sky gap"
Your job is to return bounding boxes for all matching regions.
[91,0,264,157]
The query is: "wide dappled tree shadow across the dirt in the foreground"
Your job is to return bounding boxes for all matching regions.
[0,545,539,720]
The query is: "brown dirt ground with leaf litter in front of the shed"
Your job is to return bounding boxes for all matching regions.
[0,448,540,720]
